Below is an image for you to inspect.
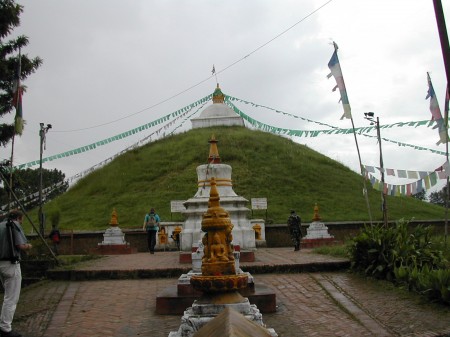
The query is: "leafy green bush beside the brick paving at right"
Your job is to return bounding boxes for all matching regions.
[349,220,450,304]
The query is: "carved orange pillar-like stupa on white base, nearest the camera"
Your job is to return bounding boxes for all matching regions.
[169,177,278,337]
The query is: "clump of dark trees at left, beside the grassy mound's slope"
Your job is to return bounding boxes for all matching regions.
[0,168,69,210]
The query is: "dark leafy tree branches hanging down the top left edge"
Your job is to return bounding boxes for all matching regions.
[0,0,42,146]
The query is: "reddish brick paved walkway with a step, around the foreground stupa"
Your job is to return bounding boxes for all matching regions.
[3,248,450,337]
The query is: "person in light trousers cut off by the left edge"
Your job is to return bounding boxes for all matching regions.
[0,211,33,337]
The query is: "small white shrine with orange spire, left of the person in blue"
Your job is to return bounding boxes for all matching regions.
[91,209,137,255]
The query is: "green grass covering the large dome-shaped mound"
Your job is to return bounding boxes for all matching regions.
[25,127,444,230]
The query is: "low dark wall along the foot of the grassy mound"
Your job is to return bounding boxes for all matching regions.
[28,220,445,254]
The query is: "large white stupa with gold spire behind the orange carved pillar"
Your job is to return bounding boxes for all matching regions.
[180,136,256,261]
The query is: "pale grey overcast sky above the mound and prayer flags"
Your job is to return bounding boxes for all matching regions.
[0,0,450,192]
